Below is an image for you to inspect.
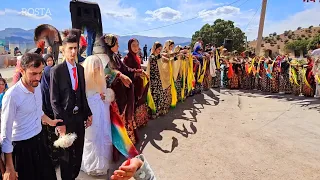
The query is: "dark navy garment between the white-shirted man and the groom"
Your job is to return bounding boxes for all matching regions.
[40,66,53,116]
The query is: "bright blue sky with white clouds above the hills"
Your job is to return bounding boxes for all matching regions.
[0,0,320,40]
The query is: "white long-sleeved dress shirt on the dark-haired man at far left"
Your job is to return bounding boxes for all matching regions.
[1,79,44,153]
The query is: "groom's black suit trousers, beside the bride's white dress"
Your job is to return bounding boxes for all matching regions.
[60,113,87,180]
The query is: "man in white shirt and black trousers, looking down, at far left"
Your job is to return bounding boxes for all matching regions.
[1,53,62,180]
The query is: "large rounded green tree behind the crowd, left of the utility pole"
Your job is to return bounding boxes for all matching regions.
[191,19,245,51]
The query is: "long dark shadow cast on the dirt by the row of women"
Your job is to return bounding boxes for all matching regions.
[136,90,220,153]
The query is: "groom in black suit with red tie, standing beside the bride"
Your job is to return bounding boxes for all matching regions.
[50,34,92,180]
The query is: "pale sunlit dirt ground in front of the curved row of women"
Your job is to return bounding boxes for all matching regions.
[65,90,320,180]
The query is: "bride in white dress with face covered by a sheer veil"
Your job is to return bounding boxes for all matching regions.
[81,55,112,176]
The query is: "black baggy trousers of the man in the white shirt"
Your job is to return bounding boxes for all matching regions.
[12,133,57,180]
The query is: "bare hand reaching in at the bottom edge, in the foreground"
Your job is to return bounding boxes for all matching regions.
[111,158,143,180]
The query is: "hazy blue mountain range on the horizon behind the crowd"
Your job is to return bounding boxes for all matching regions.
[0,28,191,53]
